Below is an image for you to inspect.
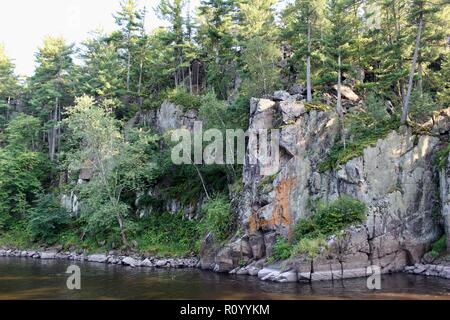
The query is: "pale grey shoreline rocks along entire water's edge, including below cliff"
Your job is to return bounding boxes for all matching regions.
[0,249,450,283]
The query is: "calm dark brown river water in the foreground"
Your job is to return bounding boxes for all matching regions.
[0,258,450,299]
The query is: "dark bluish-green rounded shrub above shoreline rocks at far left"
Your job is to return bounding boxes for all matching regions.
[28,195,70,244]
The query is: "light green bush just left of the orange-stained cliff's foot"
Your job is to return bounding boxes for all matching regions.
[200,193,234,241]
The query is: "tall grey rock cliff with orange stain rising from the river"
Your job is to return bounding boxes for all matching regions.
[201,91,450,280]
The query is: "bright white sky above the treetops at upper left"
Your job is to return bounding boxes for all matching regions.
[0,0,167,75]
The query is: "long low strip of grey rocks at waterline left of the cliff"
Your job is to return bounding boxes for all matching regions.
[0,249,198,268]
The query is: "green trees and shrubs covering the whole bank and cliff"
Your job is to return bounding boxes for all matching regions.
[0,0,450,255]
